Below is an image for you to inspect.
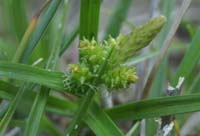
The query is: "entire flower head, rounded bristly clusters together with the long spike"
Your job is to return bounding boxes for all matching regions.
[64,16,166,95]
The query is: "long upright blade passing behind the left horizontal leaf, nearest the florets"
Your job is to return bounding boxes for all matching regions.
[24,1,65,136]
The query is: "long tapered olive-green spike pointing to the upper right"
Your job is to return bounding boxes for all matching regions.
[113,16,166,62]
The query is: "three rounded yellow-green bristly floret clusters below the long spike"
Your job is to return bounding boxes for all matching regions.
[65,37,137,94]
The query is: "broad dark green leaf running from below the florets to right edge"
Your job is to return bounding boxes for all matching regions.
[106,94,200,120]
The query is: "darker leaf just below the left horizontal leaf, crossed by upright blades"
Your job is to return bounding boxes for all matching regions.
[0,80,78,116]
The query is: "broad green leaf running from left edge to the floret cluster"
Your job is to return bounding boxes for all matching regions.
[0,62,64,90]
